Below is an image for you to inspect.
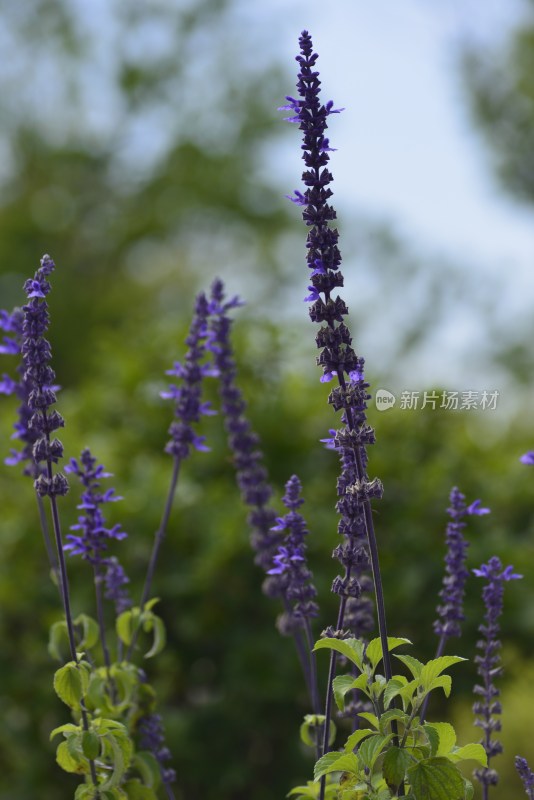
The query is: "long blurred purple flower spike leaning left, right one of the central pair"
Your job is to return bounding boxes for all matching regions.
[207,279,284,597]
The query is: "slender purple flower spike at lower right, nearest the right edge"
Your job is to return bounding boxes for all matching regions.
[473,556,523,800]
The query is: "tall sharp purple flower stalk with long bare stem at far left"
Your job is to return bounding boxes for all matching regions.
[21,255,99,797]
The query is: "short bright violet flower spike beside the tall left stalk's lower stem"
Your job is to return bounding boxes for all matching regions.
[64,448,127,564]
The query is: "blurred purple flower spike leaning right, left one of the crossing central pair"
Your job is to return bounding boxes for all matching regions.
[165,293,217,461]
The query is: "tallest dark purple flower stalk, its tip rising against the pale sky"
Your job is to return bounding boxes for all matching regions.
[282,31,392,776]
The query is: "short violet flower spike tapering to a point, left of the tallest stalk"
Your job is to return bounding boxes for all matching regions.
[267,475,318,634]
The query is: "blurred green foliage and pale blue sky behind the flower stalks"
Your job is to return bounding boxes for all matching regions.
[0,0,534,800]
